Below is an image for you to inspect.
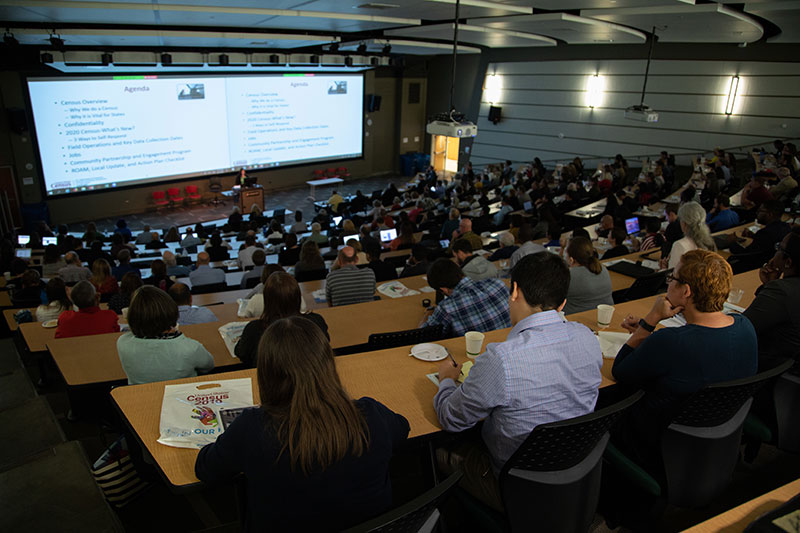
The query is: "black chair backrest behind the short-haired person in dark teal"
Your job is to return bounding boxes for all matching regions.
[661,359,792,508]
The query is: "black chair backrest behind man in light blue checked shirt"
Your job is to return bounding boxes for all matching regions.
[500,391,644,532]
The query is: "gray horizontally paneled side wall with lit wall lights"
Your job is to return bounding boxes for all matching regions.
[472,59,800,165]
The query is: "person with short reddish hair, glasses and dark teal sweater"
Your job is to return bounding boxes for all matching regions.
[612,250,758,473]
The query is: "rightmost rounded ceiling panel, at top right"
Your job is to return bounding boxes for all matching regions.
[581,4,764,43]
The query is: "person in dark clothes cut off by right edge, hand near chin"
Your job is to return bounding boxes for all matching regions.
[743,228,800,359]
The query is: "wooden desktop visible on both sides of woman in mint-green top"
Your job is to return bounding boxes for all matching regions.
[47,322,241,387]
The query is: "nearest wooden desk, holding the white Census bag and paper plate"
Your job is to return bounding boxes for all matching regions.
[111,328,613,487]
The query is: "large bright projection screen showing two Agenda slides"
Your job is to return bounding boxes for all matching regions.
[28,74,364,196]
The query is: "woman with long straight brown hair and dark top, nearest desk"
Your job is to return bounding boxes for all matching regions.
[195,317,409,531]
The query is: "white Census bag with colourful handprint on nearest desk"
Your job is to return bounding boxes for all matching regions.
[158,378,253,448]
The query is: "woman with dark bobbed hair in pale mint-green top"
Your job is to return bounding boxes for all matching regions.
[117,285,214,385]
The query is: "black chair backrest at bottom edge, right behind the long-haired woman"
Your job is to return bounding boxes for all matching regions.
[344,472,462,533]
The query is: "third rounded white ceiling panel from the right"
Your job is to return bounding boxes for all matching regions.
[383,22,558,48]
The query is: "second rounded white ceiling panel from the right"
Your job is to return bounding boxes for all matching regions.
[467,13,647,44]
